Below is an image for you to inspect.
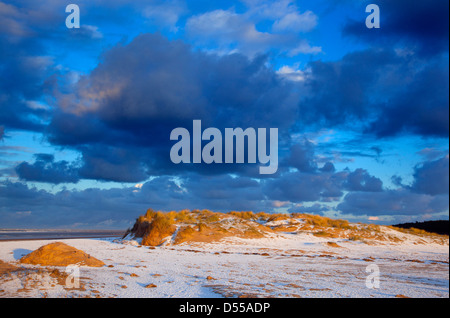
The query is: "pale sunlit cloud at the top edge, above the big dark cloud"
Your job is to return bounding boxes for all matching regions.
[185,1,322,56]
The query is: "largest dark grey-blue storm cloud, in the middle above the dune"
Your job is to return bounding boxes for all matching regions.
[47,34,297,182]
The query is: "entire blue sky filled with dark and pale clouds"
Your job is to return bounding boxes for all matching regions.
[0,0,449,229]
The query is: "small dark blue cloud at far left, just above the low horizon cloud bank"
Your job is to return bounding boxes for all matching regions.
[15,154,80,184]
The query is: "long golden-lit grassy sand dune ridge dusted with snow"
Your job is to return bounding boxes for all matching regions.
[127,209,448,246]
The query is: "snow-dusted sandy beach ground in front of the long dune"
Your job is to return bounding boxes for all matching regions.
[0,233,449,298]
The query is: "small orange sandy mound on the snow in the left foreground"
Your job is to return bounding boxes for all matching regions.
[20,242,105,267]
